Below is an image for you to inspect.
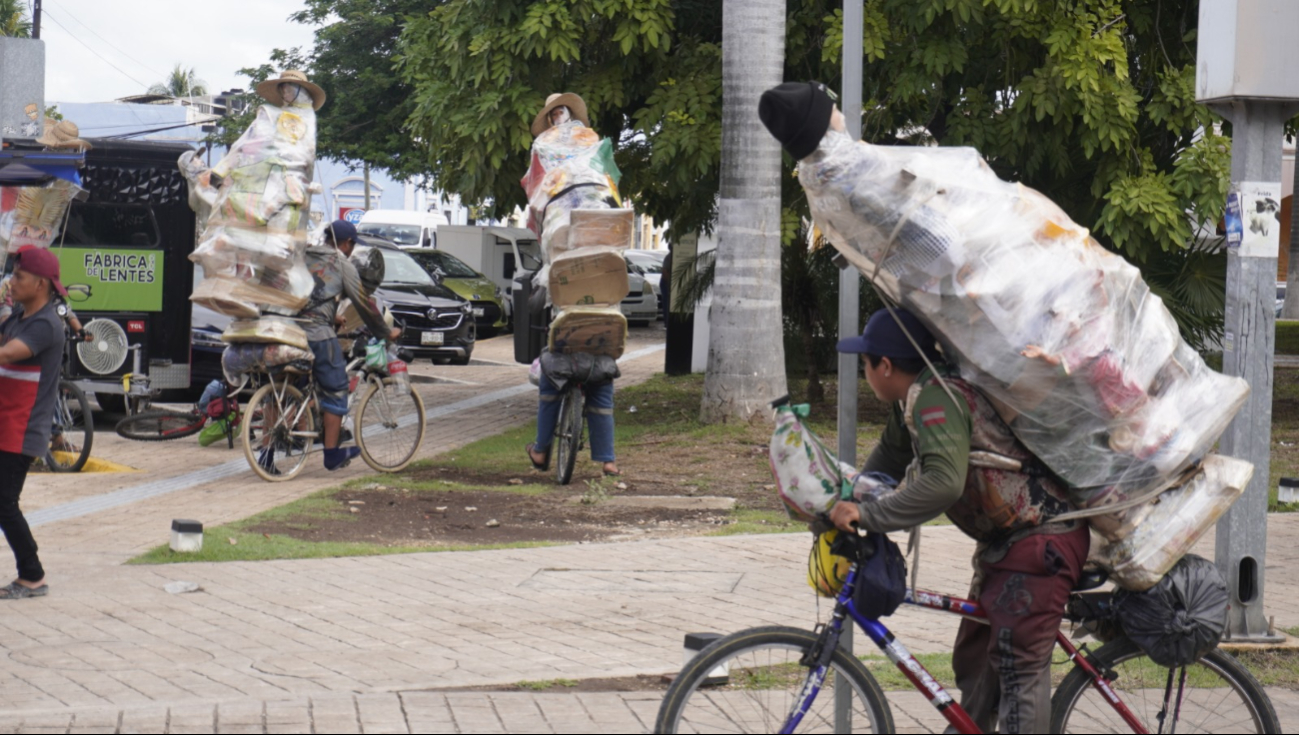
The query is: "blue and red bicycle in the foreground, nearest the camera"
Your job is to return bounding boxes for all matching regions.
[655,532,1281,732]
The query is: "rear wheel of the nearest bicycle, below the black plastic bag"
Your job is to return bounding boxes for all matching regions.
[1051,638,1281,732]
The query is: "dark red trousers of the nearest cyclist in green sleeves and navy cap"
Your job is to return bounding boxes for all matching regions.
[952,523,1091,732]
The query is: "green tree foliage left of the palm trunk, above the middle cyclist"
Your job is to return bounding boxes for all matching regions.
[399,0,721,231]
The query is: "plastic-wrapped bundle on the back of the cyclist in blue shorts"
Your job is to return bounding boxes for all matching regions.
[179,97,316,317]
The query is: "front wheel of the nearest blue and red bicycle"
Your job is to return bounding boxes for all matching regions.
[655,626,894,732]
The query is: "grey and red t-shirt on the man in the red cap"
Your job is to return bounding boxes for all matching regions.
[0,300,64,457]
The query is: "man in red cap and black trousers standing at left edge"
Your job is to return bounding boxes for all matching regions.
[0,247,68,600]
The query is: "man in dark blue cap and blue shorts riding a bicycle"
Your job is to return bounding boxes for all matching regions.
[290,219,401,470]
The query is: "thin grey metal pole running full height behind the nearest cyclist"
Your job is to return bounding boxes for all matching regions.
[834,0,865,732]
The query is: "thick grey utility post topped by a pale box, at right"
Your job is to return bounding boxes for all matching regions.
[1195,0,1299,643]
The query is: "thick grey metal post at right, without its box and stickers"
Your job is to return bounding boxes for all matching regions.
[1213,100,1299,642]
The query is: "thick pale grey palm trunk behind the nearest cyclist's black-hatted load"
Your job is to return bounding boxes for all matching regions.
[700,0,787,423]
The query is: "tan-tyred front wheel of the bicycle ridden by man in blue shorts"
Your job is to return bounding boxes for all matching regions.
[355,378,425,473]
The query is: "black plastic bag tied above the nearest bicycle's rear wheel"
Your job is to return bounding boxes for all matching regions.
[1115,554,1230,667]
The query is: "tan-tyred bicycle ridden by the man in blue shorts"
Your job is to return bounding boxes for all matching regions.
[240,340,425,482]
